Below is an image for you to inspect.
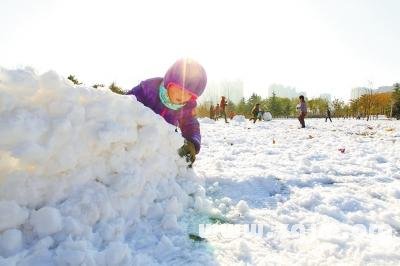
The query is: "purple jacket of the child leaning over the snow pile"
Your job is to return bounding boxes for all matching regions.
[127,78,201,153]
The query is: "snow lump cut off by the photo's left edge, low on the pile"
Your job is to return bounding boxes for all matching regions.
[0,201,29,232]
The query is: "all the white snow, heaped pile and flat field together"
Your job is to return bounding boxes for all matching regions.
[0,68,400,265]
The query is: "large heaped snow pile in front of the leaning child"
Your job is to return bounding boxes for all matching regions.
[0,69,204,265]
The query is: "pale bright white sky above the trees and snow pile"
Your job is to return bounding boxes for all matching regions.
[0,0,400,99]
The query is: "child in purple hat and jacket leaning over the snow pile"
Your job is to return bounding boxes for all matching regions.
[127,59,207,164]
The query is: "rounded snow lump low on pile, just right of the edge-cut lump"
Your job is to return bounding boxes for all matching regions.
[29,207,62,236]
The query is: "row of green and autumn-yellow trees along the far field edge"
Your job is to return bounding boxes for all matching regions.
[197,83,400,120]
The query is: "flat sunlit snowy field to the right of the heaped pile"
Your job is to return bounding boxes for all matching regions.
[196,119,400,265]
